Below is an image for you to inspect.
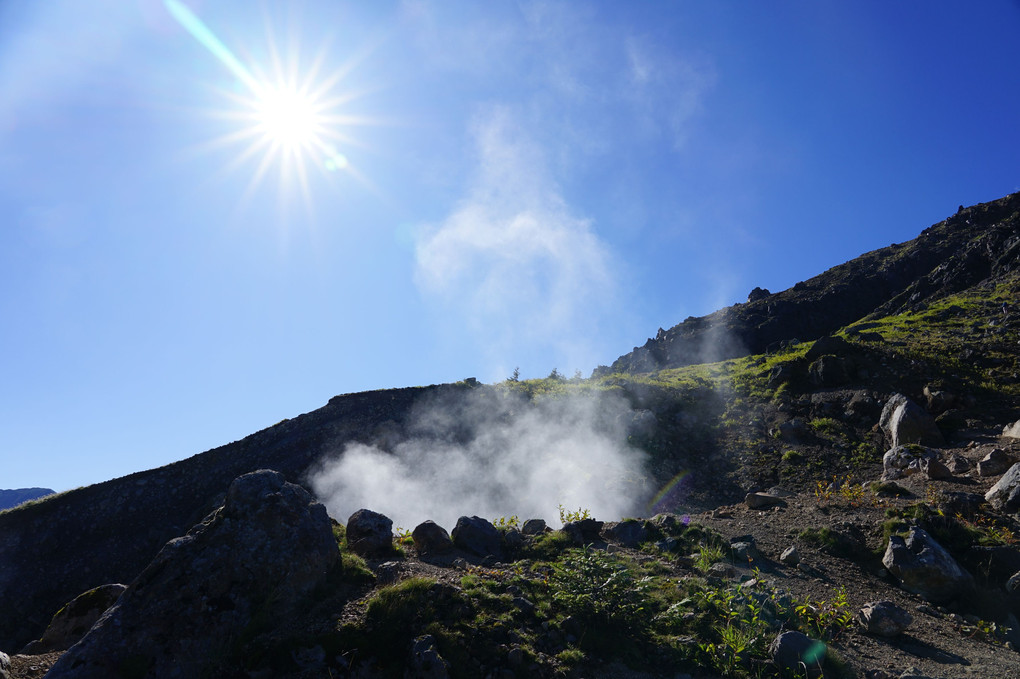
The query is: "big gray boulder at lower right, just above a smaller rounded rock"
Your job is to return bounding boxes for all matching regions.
[882,527,973,604]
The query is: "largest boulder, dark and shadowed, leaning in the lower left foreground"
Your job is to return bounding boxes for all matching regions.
[47,470,340,679]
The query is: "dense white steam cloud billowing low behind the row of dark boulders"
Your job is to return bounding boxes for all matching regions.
[310,387,648,530]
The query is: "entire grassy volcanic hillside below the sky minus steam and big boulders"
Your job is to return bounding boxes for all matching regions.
[0,194,1020,677]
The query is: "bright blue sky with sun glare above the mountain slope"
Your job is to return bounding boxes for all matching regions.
[0,0,1020,490]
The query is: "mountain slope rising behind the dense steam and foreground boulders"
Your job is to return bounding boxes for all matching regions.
[0,188,1020,664]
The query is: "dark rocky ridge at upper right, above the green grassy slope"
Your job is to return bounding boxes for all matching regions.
[595,193,1020,376]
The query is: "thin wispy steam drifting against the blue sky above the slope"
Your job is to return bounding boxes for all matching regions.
[415,107,618,374]
